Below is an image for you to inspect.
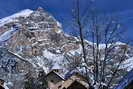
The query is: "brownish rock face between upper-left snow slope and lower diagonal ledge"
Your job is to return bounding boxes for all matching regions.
[0,8,80,71]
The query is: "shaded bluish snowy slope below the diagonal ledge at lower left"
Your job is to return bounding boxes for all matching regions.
[0,47,35,89]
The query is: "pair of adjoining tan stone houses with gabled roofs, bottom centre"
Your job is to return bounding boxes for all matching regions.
[46,70,89,89]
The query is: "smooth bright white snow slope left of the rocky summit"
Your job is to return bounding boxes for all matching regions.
[0,9,33,27]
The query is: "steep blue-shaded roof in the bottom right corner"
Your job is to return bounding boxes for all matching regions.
[114,69,133,89]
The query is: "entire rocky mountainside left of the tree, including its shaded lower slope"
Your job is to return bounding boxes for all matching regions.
[0,8,80,89]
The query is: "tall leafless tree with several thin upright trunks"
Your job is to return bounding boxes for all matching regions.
[64,0,127,89]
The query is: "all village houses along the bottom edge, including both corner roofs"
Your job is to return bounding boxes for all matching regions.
[0,69,133,89]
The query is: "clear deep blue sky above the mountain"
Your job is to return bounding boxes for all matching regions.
[0,0,133,40]
